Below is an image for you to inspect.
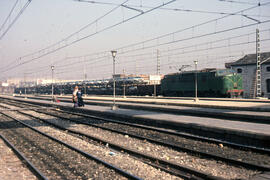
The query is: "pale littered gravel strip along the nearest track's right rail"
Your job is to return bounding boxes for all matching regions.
[0,103,184,179]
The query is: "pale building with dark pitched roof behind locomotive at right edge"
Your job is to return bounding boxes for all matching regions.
[225,52,270,98]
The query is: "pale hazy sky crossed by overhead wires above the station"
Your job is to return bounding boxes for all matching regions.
[0,0,270,80]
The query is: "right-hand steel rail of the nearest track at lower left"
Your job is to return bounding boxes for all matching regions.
[0,114,141,180]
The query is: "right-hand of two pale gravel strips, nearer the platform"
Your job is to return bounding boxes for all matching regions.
[15,107,257,179]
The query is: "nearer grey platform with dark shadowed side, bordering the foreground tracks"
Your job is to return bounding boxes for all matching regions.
[1,97,270,149]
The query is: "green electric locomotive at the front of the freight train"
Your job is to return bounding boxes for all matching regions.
[161,69,243,97]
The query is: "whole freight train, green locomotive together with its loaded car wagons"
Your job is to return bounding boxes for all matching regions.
[15,69,243,97]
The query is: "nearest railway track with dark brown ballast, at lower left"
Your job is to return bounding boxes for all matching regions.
[1,112,140,179]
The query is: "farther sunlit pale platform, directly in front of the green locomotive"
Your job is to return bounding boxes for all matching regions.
[20,95,270,112]
